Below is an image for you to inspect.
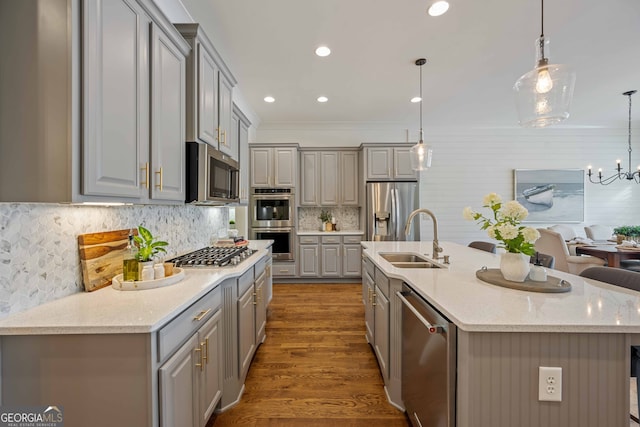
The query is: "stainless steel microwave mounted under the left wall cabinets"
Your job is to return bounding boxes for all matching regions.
[186,142,240,204]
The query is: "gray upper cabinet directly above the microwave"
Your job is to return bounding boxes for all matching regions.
[175,24,238,160]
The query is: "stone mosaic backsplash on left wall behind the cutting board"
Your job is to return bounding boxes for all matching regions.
[0,203,229,318]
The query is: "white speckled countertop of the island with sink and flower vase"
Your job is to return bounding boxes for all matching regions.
[362,241,640,333]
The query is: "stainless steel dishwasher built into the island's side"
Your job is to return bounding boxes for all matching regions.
[397,283,457,427]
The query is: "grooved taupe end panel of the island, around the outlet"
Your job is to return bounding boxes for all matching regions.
[457,330,630,427]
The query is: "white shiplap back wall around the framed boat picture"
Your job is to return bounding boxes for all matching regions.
[256,123,640,244]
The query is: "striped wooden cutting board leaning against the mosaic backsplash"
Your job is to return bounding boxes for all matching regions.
[78,228,138,292]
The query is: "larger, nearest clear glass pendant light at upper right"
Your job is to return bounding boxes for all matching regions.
[513,0,576,127]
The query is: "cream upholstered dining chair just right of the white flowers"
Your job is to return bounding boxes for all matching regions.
[535,228,605,274]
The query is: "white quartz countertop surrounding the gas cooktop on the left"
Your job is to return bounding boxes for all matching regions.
[0,240,273,335]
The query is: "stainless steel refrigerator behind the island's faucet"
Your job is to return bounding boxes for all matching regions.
[366,182,420,240]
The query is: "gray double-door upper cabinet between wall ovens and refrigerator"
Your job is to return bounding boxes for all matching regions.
[300,150,359,206]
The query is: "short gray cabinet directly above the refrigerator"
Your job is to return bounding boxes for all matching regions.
[365,145,416,181]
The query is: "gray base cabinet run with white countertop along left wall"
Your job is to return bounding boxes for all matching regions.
[0,241,273,427]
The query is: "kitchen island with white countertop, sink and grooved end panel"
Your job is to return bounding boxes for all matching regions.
[362,242,640,427]
